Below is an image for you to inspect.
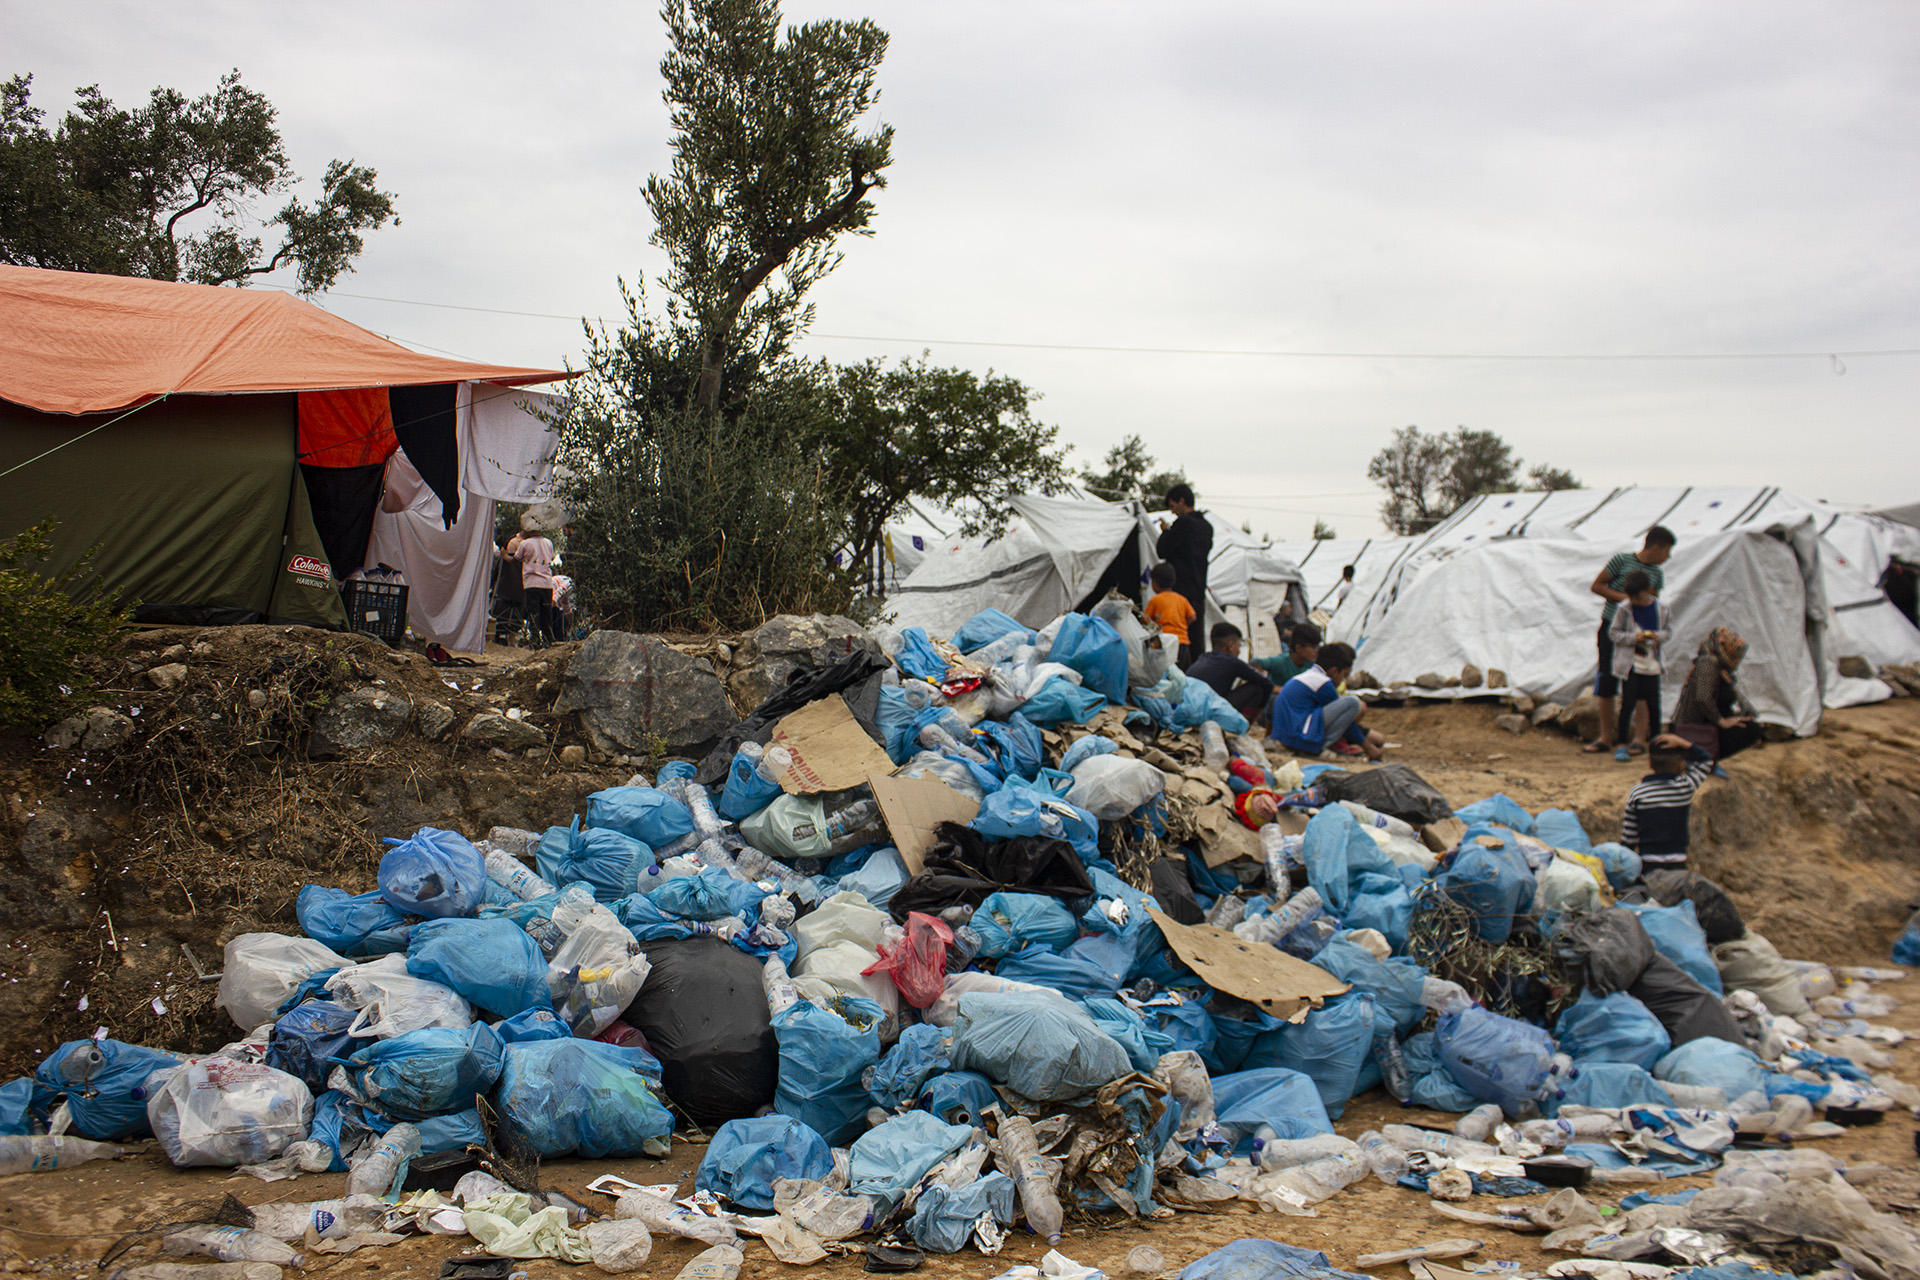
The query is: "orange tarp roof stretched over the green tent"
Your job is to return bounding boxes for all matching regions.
[0,267,572,413]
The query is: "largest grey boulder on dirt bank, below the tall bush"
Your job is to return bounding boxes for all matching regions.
[553,631,737,756]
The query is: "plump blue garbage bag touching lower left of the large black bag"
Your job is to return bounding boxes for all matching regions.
[493,1038,674,1159]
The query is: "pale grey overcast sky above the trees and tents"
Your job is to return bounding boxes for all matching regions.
[0,0,1920,539]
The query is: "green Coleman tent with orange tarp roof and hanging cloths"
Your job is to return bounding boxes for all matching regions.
[0,267,568,649]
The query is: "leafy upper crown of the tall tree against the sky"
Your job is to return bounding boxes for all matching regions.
[645,0,893,413]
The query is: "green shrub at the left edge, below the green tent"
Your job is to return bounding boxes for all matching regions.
[0,520,127,727]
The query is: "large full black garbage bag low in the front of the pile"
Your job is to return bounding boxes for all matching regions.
[624,938,780,1125]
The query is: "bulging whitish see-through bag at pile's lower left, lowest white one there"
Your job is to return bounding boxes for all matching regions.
[146,1057,313,1169]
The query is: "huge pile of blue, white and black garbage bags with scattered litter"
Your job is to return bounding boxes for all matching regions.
[0,601,1920,1280]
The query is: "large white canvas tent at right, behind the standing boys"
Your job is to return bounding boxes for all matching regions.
[1331,487,1920,733]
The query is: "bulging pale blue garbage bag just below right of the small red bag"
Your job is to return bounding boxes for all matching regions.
[950,992,1133,1102]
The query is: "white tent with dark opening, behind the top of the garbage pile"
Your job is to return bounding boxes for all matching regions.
[887,495,1154,637]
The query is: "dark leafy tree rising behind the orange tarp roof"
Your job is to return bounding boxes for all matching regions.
[0,71,397,294]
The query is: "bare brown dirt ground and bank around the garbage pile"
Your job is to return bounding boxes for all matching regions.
[0,628,1920,1280]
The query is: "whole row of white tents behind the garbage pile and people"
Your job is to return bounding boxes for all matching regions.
[887,486,1920,733]
